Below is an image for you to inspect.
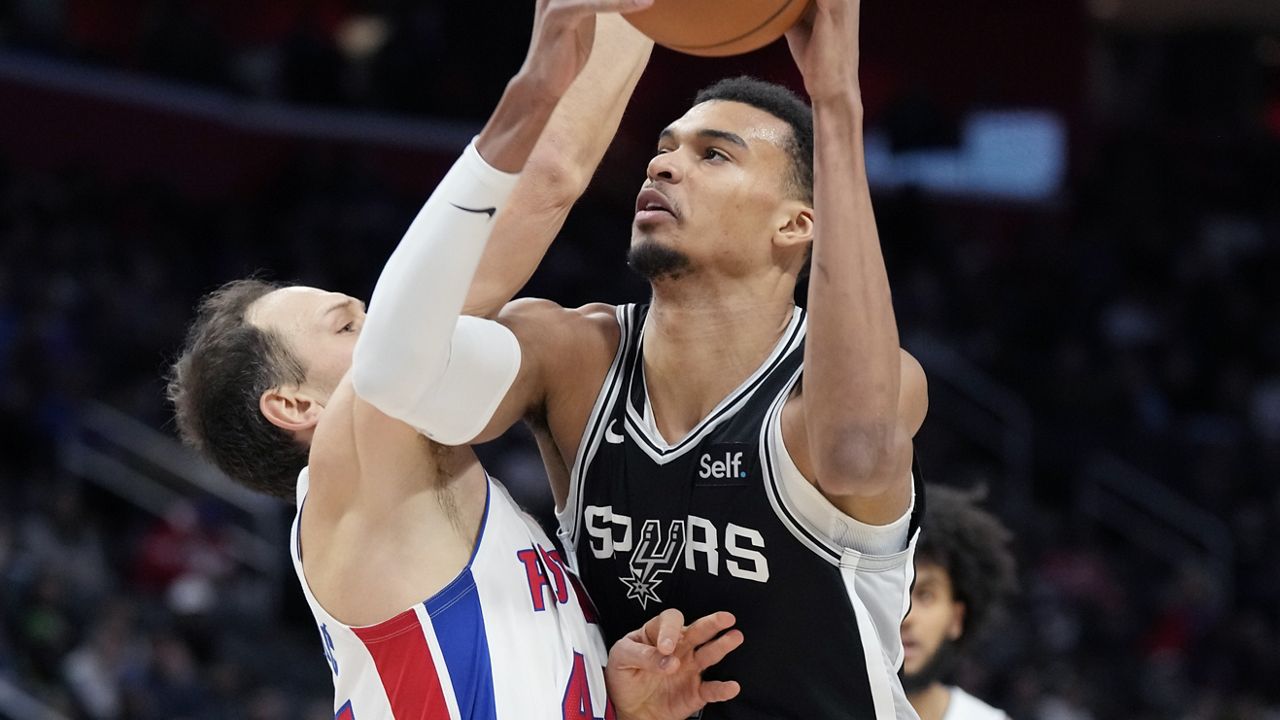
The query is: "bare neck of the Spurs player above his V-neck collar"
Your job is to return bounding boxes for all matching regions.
[644,275,795,442]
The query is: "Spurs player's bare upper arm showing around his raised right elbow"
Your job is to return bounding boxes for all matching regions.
[782,350,929,525]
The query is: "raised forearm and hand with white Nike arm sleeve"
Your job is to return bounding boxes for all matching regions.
[351,0,652,445]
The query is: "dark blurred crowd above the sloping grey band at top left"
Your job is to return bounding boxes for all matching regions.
[0,0,532,118]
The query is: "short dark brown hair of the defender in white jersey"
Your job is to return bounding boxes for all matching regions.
[168,279,307,498]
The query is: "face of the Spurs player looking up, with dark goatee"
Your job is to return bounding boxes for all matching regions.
[631,100,803,274]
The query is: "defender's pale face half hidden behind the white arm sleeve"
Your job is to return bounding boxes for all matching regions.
[248,286,365,401]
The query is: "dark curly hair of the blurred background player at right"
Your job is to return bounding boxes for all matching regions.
[915,484,1018,643]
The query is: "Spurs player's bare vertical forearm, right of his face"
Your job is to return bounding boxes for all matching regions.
[804,87,901,495]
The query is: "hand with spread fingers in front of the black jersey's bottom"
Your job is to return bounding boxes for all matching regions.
[604,610,742,720]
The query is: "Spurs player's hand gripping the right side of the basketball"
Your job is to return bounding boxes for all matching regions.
[787,0,861,105]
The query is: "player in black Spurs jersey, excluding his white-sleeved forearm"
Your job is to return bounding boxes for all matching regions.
[465,0,927,720]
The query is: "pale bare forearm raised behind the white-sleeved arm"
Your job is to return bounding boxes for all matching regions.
[463,15,653,316]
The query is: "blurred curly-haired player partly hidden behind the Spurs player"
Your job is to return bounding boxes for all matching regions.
[902,486,1016,720]
